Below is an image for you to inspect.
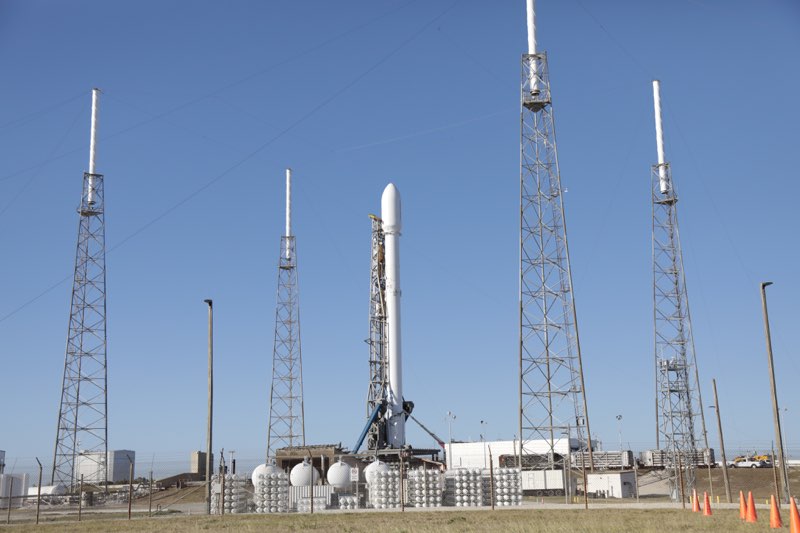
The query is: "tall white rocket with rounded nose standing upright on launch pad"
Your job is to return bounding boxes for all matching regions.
[381,183,406,448]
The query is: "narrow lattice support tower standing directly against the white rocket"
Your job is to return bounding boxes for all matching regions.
[367,215,388,450]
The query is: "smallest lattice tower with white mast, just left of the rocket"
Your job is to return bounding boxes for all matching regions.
[267,169,306,460]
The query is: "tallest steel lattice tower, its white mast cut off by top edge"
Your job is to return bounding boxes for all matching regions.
[519,0,592,469]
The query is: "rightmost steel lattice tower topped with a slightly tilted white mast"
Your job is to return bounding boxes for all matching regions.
[651,80,708,499]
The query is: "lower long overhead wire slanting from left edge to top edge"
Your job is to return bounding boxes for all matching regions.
[0,0,459,323]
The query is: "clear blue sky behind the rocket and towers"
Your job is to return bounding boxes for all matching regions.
[0,0,800,478]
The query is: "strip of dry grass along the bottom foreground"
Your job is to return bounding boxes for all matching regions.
[0,509,788,533]
